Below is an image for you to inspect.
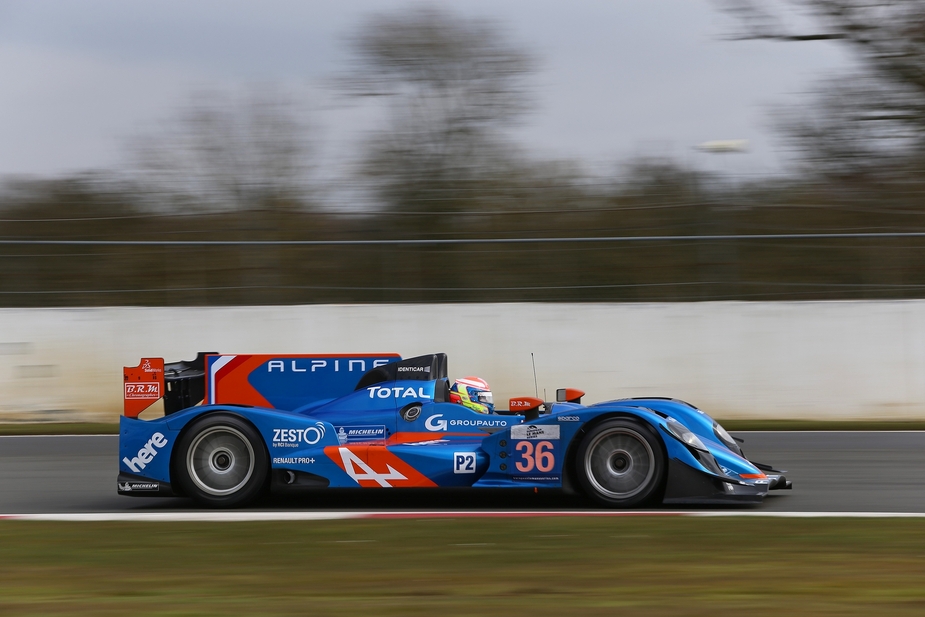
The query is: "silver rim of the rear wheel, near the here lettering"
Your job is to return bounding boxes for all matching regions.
[186,426,254,495]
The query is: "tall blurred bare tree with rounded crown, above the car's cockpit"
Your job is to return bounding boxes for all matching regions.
[343,7,533,210]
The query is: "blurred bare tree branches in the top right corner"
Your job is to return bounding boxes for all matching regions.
[723,0,925,175]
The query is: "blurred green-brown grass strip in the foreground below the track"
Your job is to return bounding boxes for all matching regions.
[0,517,925,617]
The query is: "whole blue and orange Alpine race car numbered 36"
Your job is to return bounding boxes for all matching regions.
[118,353,790,508]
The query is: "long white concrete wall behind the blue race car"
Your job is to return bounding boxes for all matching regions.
[0,300,925,421]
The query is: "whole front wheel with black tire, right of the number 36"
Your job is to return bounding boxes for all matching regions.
[575,418,668,508]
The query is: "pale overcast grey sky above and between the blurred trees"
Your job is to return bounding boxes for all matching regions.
[0,0,849,176]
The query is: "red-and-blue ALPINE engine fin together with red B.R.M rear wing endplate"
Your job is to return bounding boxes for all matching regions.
[123,352,401,418]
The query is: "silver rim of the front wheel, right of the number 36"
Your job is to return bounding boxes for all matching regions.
[584,428,656,499]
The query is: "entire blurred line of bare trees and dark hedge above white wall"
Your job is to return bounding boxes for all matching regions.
[0,0,925,306]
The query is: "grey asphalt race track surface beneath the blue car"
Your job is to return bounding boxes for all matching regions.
[0,431,925,514]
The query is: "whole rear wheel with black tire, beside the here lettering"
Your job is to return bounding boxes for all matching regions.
[174,414,270,508]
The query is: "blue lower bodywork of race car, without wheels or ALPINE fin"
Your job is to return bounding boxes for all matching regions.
[119,352,783,503]
